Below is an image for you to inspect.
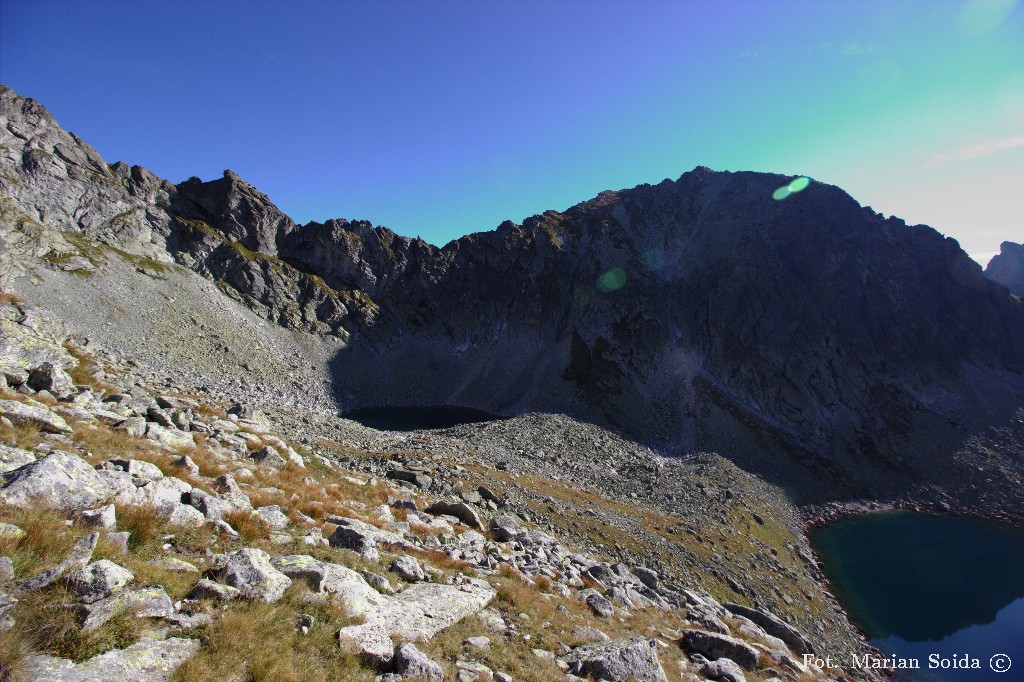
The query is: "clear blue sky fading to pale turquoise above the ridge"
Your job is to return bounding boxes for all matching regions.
[0,0,1024,260]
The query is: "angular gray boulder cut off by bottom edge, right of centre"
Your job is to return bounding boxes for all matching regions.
[565,637,668,682]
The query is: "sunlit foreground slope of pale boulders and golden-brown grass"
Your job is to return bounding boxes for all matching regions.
[0,295,873,682]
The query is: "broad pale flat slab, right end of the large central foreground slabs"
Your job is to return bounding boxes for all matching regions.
[367,581,495,641]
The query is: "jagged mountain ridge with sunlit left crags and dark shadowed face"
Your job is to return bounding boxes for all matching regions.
[6,82,1024,500]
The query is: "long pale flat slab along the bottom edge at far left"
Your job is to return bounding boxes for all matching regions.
[25,637,200,682]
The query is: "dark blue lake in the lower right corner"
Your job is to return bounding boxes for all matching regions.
[810,512,1024,682]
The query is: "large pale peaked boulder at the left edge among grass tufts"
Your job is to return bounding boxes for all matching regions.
[0,451,111,509]
